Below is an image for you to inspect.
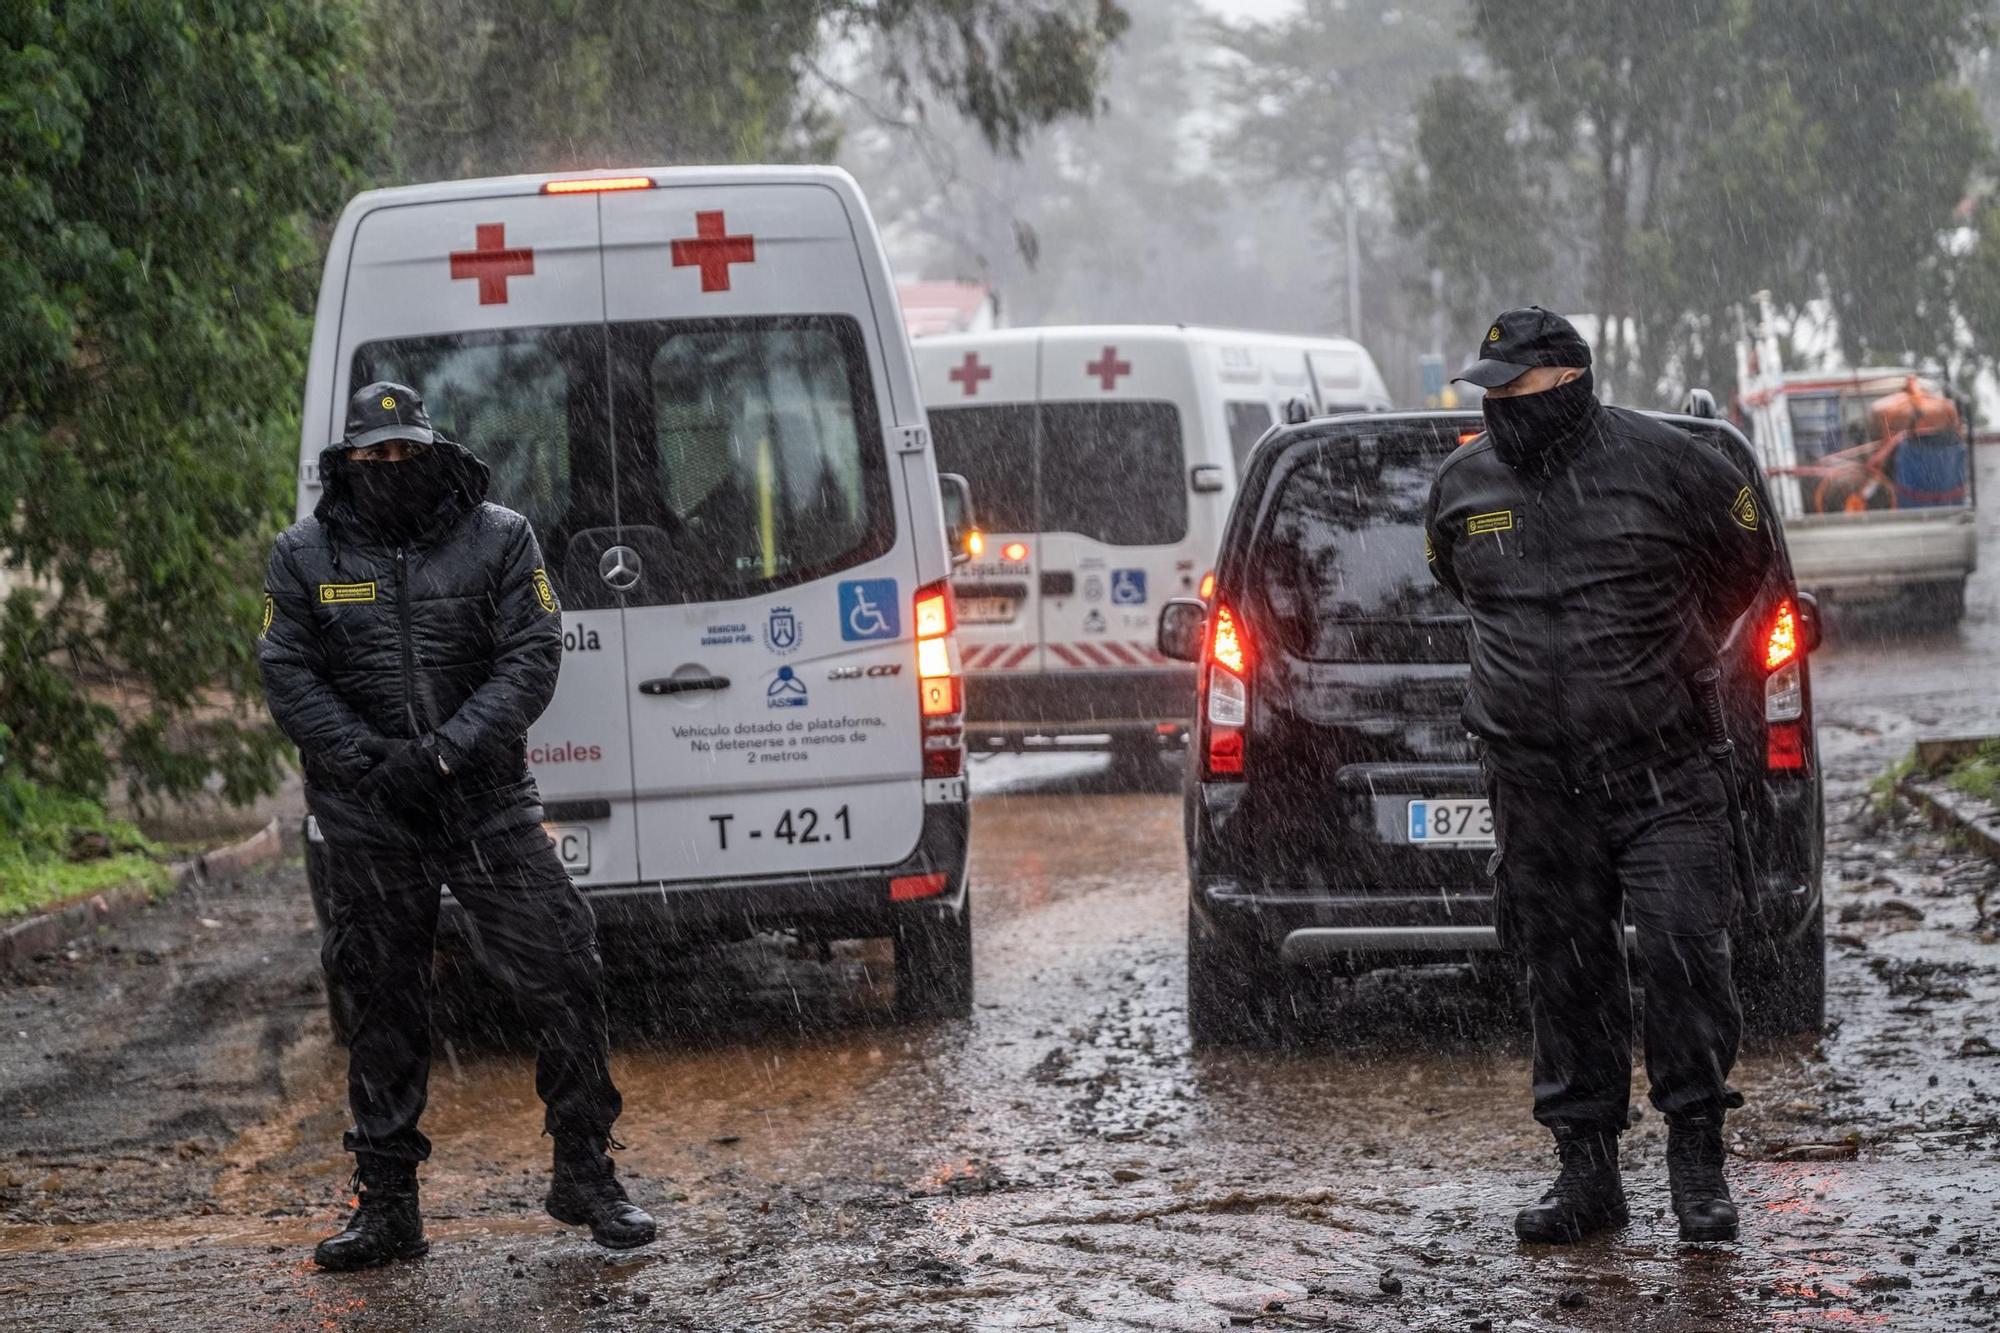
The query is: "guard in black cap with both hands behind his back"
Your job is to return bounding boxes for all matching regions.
[1428,306,1772,1243]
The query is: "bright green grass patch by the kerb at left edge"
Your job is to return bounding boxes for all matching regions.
[0,777,170,921]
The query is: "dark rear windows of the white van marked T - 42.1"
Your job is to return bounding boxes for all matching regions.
[352,316,896,606]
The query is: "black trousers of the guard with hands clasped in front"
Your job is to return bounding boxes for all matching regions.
[320,825,622,1161]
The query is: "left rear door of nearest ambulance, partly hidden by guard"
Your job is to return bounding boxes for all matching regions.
[330,182,638,885]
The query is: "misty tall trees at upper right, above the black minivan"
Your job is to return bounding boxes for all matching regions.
[1404,0,1990,398]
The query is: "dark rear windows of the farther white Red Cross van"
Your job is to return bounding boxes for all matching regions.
[930,402,1188,546]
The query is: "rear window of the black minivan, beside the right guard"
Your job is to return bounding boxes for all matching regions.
[1250,430,1470,662]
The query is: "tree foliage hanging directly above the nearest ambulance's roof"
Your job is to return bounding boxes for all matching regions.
[362,0,1126,180]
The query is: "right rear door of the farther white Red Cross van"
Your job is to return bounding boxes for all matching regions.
[1036,332,1206,673]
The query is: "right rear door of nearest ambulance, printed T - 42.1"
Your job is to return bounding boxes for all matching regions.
[598,180,942,883]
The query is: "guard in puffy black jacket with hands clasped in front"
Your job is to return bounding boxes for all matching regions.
[258,382,654,1269]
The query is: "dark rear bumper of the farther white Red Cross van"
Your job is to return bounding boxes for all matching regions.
[966,664,1194,751]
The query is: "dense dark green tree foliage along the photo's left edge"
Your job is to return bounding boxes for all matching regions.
[0,0,374,799]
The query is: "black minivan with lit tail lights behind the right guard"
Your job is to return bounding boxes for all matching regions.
[1160,404,1826,1043]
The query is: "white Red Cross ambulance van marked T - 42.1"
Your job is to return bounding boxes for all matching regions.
[298,168,972,1015]
